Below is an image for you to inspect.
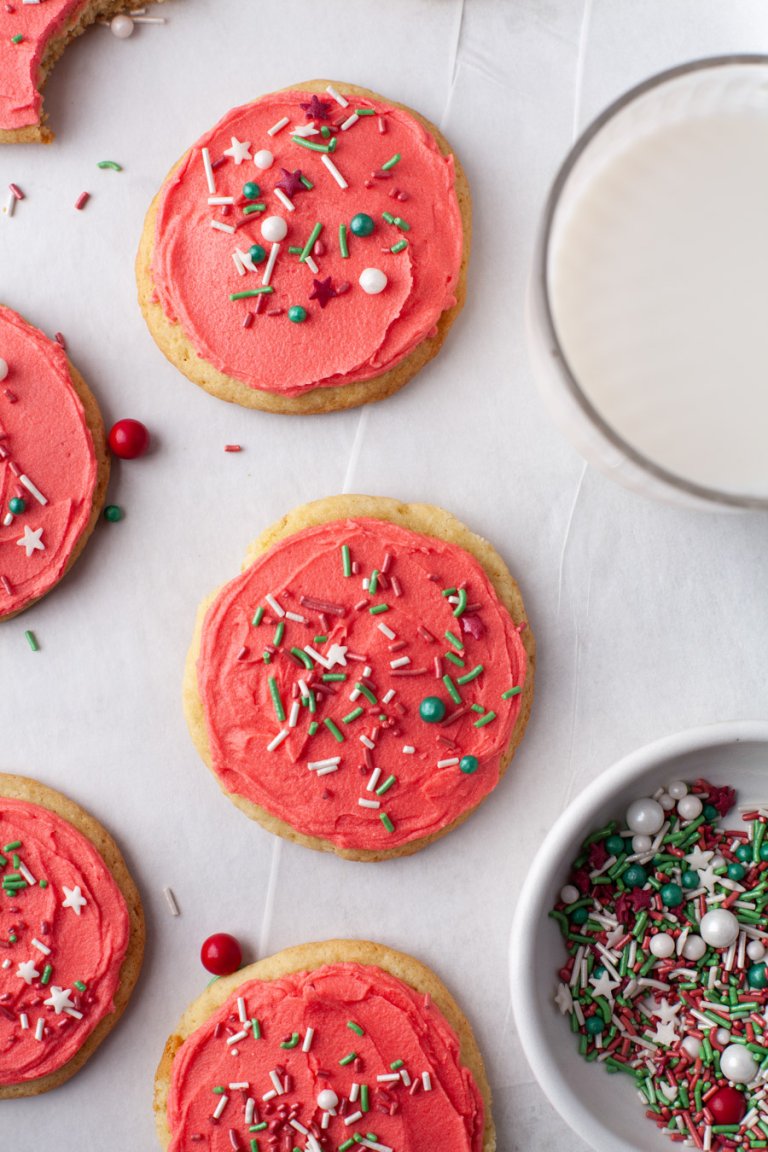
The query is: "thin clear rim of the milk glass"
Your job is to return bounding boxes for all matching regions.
[531,52,768,509]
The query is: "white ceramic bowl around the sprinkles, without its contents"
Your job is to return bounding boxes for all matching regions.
[510,721,768,1152]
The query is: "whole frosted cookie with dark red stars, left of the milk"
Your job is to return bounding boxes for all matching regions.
[137,81,471,412]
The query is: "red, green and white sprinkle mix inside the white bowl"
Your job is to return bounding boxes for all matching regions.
[550,780,768,1152]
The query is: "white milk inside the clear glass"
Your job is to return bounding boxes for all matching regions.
[547,111,768,498]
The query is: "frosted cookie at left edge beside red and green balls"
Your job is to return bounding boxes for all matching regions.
[0,305,109,620]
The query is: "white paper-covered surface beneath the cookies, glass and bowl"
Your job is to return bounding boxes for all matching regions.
[0,0,768,1152]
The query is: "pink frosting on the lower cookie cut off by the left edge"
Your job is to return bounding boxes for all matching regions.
[0,797,130,1084]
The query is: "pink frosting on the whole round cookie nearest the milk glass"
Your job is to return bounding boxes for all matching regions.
[152,92,463,396]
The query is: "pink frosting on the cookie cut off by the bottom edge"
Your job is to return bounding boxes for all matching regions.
[167,963,484,1152]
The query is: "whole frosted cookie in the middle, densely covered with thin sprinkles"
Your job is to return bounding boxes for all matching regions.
[184,497,534,861]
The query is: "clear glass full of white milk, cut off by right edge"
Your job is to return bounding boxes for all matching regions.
[527,55,768,508]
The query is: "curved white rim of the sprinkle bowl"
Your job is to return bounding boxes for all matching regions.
[509,720,768,1152]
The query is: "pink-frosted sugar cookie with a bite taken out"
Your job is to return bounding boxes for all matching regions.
[0,0,166,144]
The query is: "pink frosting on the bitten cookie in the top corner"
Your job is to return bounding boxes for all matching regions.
[0,0,89,130]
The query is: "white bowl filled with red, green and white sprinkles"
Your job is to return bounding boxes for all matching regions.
[510,721,768,1152]
